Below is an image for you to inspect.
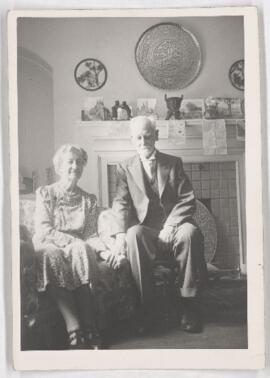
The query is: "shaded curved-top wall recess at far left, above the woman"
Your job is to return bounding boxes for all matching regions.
[18,49,54,185]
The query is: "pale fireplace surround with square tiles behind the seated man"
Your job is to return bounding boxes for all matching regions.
[75,120,246,273]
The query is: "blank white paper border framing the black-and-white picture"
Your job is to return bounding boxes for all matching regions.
[8,7,264,370]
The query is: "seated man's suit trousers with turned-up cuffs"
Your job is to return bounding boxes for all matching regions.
[127,222,207,305]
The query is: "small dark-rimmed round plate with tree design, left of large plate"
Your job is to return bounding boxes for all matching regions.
[74,58,107,91]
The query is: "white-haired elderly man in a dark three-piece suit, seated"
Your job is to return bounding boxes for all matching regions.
[111,116,206,332]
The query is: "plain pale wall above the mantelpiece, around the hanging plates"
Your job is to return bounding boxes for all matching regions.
[18,17,244,152]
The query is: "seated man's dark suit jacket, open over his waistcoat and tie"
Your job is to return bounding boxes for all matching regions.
[113,151,195,234]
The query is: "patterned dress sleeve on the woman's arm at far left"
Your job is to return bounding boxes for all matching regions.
[33,187,75,249]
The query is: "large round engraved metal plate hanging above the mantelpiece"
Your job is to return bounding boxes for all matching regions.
[135,23,201,90]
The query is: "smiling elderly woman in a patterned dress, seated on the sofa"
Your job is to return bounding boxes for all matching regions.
[33,144,111,349]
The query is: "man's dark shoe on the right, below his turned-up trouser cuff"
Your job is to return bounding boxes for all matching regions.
[180,298,203,333]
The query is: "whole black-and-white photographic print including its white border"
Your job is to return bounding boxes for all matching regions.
[9,8,263,369]
